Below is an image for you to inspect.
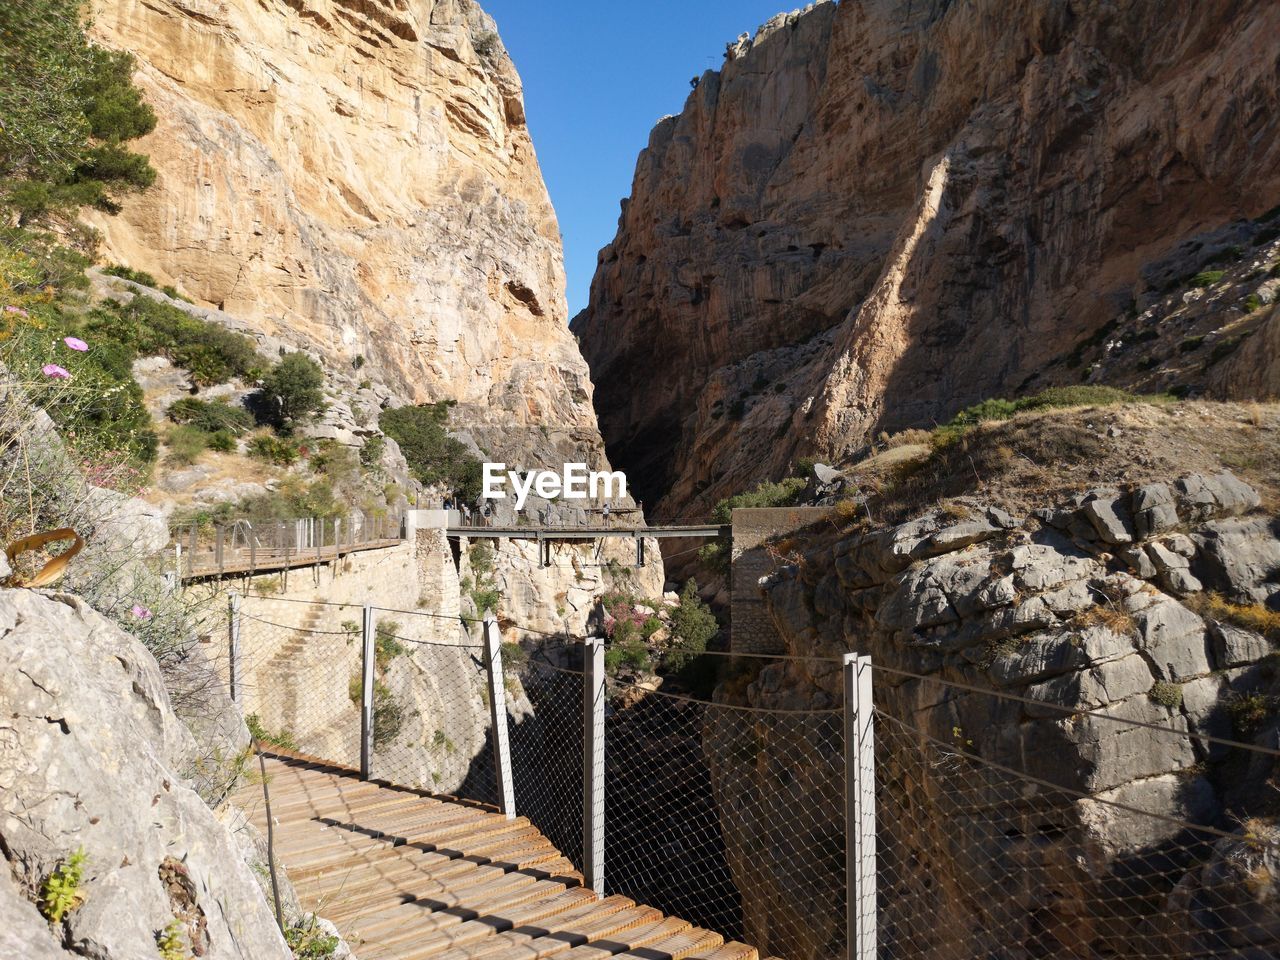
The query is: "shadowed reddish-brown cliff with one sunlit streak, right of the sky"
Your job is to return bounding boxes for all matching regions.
[573,0,1280,516]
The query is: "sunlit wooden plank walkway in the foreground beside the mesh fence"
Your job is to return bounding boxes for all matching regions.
[237,756,758,960]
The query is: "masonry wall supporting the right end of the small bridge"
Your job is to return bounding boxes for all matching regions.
[731,507,831,653]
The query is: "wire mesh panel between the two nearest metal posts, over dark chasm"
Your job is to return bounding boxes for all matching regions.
[604,654,846,957]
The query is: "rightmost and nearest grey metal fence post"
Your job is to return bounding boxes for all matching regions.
[845,653,876,960]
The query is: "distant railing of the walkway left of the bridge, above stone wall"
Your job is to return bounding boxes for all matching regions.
[168,512,403,579]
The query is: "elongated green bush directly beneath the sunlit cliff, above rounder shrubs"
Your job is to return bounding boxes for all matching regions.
[86,296,261,387]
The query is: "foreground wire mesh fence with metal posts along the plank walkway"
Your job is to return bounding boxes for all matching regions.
[228,598,1280,960]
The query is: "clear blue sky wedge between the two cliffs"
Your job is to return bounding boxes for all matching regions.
[481,0,803,316]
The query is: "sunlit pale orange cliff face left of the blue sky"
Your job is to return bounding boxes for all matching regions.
[93,0,599,466]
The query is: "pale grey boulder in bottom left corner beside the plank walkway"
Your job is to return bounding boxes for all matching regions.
[0,590,292,960]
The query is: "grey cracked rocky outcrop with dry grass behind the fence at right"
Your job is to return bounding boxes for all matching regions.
[707,472,1280,957]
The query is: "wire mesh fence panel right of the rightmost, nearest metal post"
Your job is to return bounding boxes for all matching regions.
[876,671,1280,960]
